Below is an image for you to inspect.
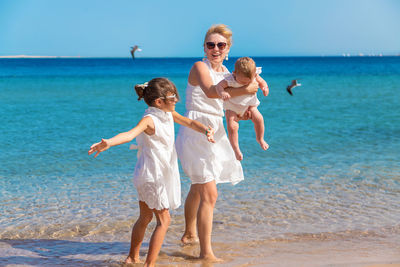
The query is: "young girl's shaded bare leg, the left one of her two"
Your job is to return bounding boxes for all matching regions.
[125,201,153,264]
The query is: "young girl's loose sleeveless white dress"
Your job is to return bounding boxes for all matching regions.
[133,107,181,210]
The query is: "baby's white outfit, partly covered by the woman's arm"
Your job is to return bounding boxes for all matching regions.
[224,67,261,116]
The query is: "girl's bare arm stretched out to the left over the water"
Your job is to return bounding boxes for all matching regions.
[88,117,154,157]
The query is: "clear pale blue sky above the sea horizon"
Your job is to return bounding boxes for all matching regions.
[0,0,400,57]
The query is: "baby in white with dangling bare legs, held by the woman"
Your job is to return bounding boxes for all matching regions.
[216,57,269,160]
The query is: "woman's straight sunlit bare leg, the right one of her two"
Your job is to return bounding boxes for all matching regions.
[192,181,218,260]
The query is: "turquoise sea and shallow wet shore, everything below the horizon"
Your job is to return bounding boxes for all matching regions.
[0,57,400,266]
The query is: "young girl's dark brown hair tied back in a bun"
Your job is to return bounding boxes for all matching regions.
[135,78,179,106]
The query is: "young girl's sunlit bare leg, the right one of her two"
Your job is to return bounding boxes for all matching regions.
[144,209,171,267]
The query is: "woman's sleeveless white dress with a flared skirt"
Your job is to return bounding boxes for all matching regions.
[176,61,244,184]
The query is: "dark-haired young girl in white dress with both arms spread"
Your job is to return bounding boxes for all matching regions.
[89,78,214,266]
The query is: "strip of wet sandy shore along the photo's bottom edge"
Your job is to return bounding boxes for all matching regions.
[0,238,400,267]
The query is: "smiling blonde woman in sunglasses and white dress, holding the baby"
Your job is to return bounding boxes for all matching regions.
[176,24,258,261]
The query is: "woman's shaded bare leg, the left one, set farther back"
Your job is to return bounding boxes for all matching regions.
[181,185,200,245]
